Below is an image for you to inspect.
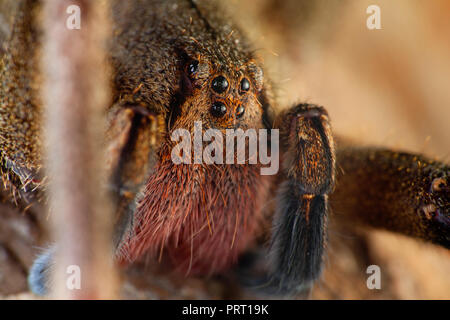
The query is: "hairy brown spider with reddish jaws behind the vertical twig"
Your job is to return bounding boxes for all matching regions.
[0,0,450,296]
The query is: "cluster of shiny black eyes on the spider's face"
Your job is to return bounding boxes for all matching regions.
[188,60,250,118]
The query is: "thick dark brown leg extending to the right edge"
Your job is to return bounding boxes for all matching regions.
[330,146,450,248]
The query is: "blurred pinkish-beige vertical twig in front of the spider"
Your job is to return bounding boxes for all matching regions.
[42,0,115,299]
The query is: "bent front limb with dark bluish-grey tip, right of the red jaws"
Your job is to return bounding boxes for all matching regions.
[239,104,335,296]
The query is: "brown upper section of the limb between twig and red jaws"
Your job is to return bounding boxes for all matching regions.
[106,106,163,251]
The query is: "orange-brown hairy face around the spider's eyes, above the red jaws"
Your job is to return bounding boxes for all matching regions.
[174,56,263,131]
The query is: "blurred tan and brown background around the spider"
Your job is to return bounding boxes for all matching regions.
[0,0,450,299]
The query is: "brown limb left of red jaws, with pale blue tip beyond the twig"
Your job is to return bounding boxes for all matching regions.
[28,105,163,295]
